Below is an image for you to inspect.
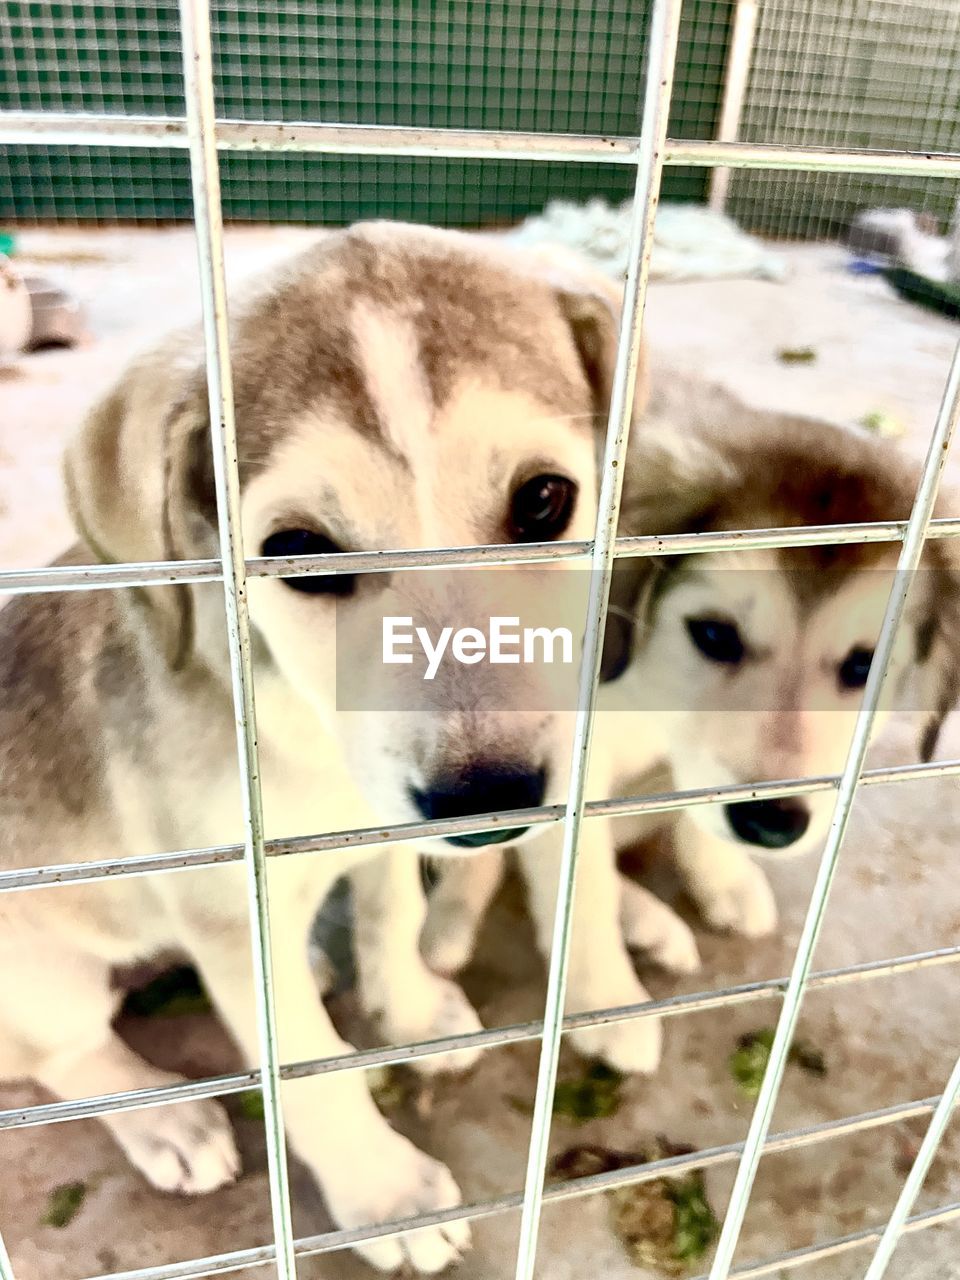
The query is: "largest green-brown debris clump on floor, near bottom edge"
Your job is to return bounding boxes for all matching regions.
[552,1138,719,1276]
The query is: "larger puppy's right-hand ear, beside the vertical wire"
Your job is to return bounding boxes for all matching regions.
[530,244,649,426]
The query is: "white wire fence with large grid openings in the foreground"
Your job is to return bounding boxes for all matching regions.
[0,0,960,1280]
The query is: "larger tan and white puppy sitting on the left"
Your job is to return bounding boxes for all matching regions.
[0,224,655,1272]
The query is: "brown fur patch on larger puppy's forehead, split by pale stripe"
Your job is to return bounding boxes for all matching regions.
[220,224,591,474]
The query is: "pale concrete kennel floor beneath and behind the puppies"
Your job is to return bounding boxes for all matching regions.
[0,229,960,1280]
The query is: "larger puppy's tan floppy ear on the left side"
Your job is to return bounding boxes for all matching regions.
[65,335,212,668]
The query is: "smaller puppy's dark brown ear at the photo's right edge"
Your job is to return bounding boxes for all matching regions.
[915,539,960,763]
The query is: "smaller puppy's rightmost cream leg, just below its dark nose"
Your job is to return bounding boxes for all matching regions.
[675,813,777,938]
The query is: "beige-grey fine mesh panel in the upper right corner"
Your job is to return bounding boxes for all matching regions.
[727,0,960,239]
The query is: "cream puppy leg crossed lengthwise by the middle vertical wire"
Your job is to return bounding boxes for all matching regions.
[517,818,662,1073]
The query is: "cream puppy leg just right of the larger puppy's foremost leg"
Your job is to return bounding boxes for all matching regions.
[351,846,483,1075]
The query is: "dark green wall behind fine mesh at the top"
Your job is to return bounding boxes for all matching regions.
[0,0,732,225]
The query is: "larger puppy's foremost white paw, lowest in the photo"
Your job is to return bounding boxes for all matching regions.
[326,1133,470,1275]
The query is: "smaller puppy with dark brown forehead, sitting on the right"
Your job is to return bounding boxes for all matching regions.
[412,372,960,1062]
